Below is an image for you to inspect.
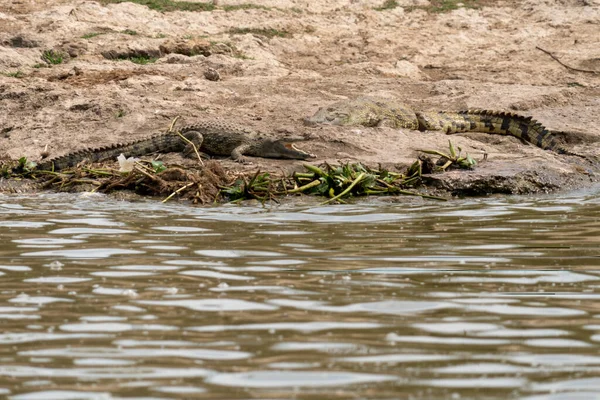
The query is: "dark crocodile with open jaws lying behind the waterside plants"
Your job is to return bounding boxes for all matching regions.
[37,120,314,171]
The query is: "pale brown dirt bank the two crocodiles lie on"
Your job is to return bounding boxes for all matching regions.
[0,0,600,198]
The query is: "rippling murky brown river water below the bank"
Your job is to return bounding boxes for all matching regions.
[0,190,600,400]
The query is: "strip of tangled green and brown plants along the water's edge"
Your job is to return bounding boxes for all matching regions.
[0,138,474,204]
